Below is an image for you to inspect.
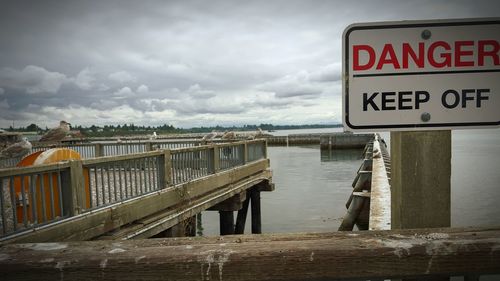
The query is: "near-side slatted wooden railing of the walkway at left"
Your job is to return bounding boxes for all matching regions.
[0,140,266,240]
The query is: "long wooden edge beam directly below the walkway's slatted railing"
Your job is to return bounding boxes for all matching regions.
[0,159,271,244]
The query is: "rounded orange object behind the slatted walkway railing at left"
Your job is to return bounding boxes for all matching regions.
[14,148,90,223]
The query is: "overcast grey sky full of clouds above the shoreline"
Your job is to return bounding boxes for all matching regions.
[0,0,500,127]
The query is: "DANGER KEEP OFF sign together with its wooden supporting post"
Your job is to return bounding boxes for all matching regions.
[343,18,500,228]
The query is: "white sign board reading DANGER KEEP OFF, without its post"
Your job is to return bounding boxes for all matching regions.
[343,18,500,131]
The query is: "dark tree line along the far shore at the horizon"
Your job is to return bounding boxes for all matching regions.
[1,123,342,137]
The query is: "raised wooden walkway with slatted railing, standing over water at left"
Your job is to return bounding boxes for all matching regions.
[0,140,273,243]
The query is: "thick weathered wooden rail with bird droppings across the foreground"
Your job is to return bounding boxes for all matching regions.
[0,228,500,280]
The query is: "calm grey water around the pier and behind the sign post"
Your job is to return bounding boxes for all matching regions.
[199,128,500,235]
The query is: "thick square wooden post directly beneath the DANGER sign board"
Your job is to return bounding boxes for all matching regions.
[391,130,451,229]
